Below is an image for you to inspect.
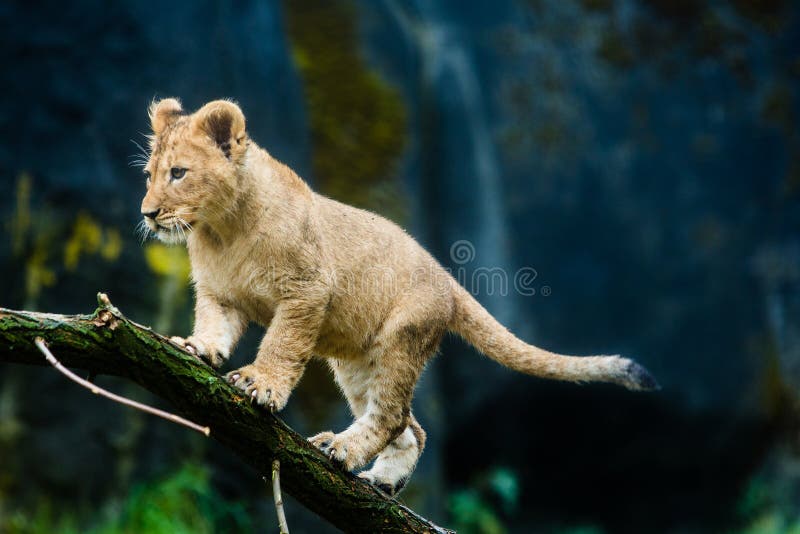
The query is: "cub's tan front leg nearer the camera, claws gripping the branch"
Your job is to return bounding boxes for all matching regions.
[226,300,324,412]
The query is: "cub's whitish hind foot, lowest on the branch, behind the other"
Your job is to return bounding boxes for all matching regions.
[358,415,425,496]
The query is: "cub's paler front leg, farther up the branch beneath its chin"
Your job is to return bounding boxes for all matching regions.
[171,288,247,367]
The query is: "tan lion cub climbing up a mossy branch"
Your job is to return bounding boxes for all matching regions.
[142,98,657,495]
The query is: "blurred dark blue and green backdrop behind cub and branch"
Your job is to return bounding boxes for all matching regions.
[0,0,800,533]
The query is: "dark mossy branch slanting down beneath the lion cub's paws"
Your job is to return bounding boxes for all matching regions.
[0,294,451,533]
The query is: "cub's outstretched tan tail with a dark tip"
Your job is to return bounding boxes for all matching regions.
[449,280,660,391]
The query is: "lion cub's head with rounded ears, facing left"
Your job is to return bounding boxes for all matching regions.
[142,98,247,243]
